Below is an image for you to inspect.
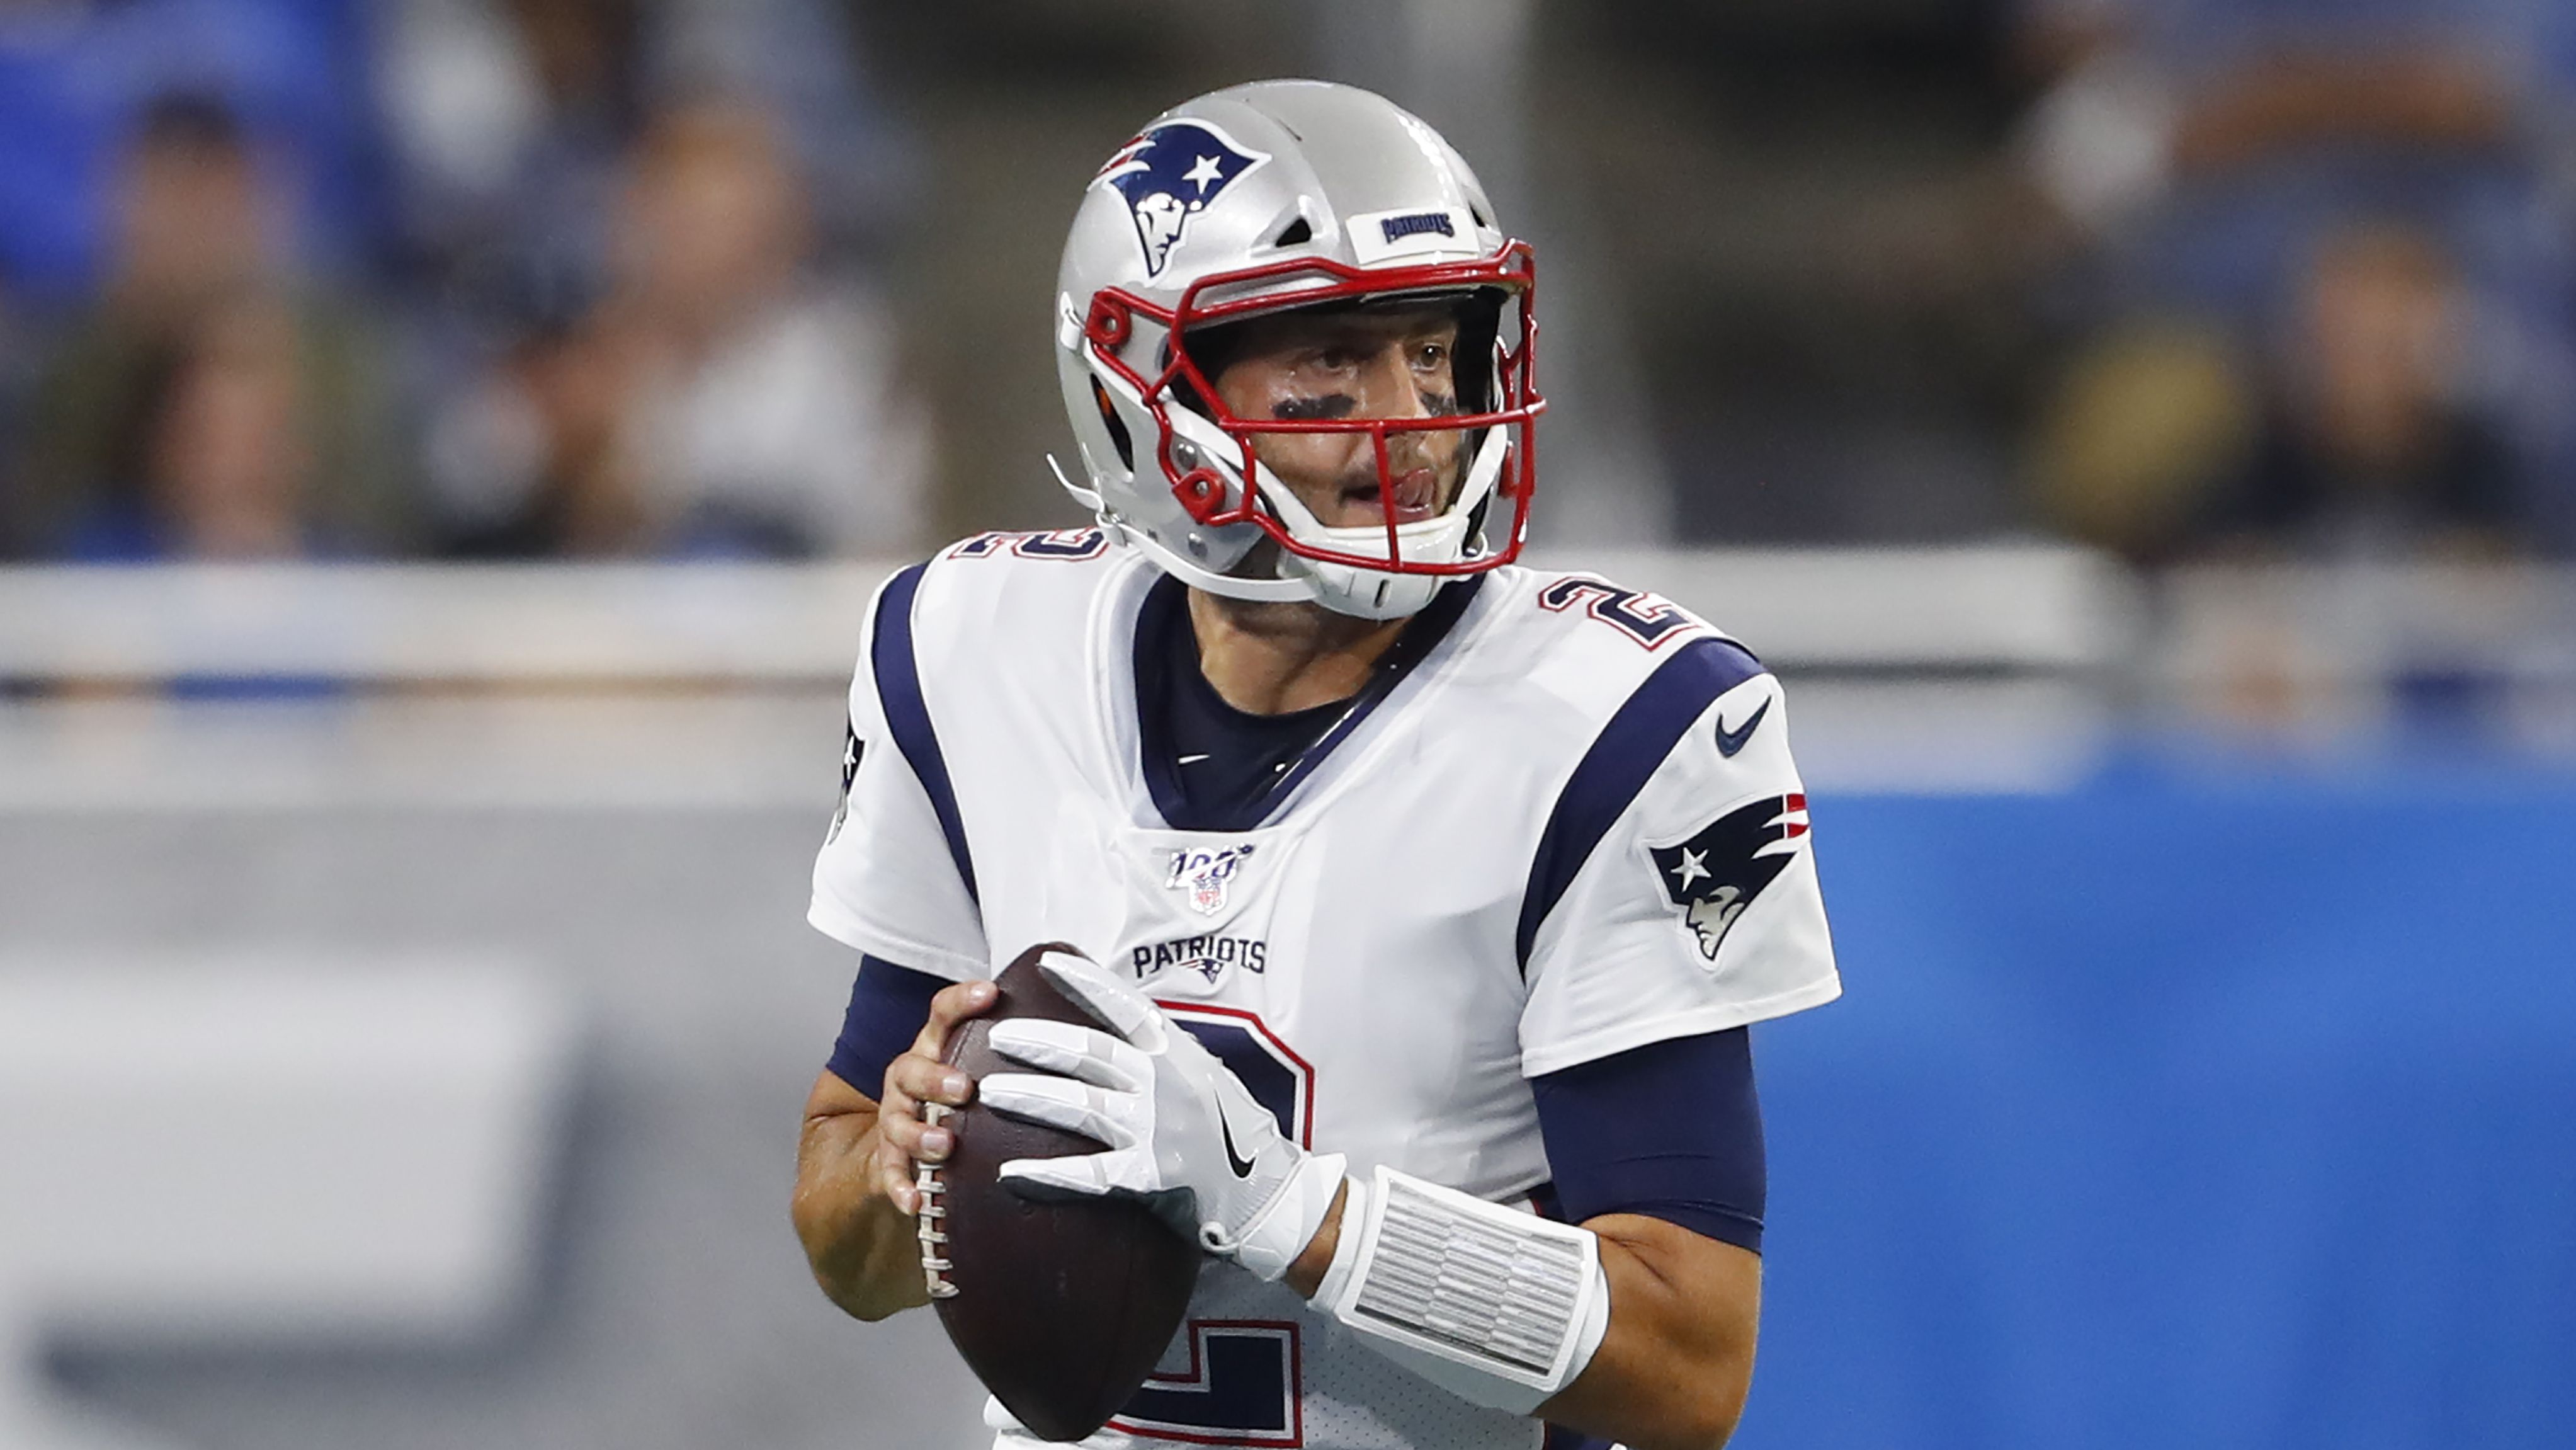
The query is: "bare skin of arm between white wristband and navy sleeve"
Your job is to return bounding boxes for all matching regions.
[1538,1213,1762,1450]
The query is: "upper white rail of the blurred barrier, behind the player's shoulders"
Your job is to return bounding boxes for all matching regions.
[0,544,2135,685]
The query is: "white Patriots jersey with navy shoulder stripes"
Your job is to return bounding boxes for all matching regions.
[812,530,1839,1450]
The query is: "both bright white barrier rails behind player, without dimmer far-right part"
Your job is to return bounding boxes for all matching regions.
[0,546,2138,819]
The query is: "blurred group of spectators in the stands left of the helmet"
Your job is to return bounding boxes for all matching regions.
[0,0,933,561]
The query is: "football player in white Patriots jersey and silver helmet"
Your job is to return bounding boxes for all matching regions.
[796,83,1839,1450]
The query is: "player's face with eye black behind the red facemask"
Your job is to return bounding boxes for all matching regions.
[1211,307,1466,528]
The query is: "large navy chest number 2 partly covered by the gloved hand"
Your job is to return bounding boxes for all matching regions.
[1110,1002,1314,1447]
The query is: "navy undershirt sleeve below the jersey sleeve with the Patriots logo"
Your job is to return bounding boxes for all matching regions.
[1530,1027,1767,1254]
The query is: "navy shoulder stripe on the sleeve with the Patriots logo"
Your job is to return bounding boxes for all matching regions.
[1512,639,1762,971]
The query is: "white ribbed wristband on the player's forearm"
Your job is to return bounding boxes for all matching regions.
[1314,1167,1610,1414]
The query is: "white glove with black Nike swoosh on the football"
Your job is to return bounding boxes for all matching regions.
[976,953,1345,1280]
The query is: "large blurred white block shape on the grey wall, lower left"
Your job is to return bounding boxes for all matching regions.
[0,958,574,1445]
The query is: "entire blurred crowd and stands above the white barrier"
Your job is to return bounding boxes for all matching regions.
[0,0,2576,564]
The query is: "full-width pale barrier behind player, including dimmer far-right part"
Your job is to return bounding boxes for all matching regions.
[25,556,2576,798]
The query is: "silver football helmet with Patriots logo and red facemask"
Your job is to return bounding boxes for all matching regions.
[1056,80,1543,618]
